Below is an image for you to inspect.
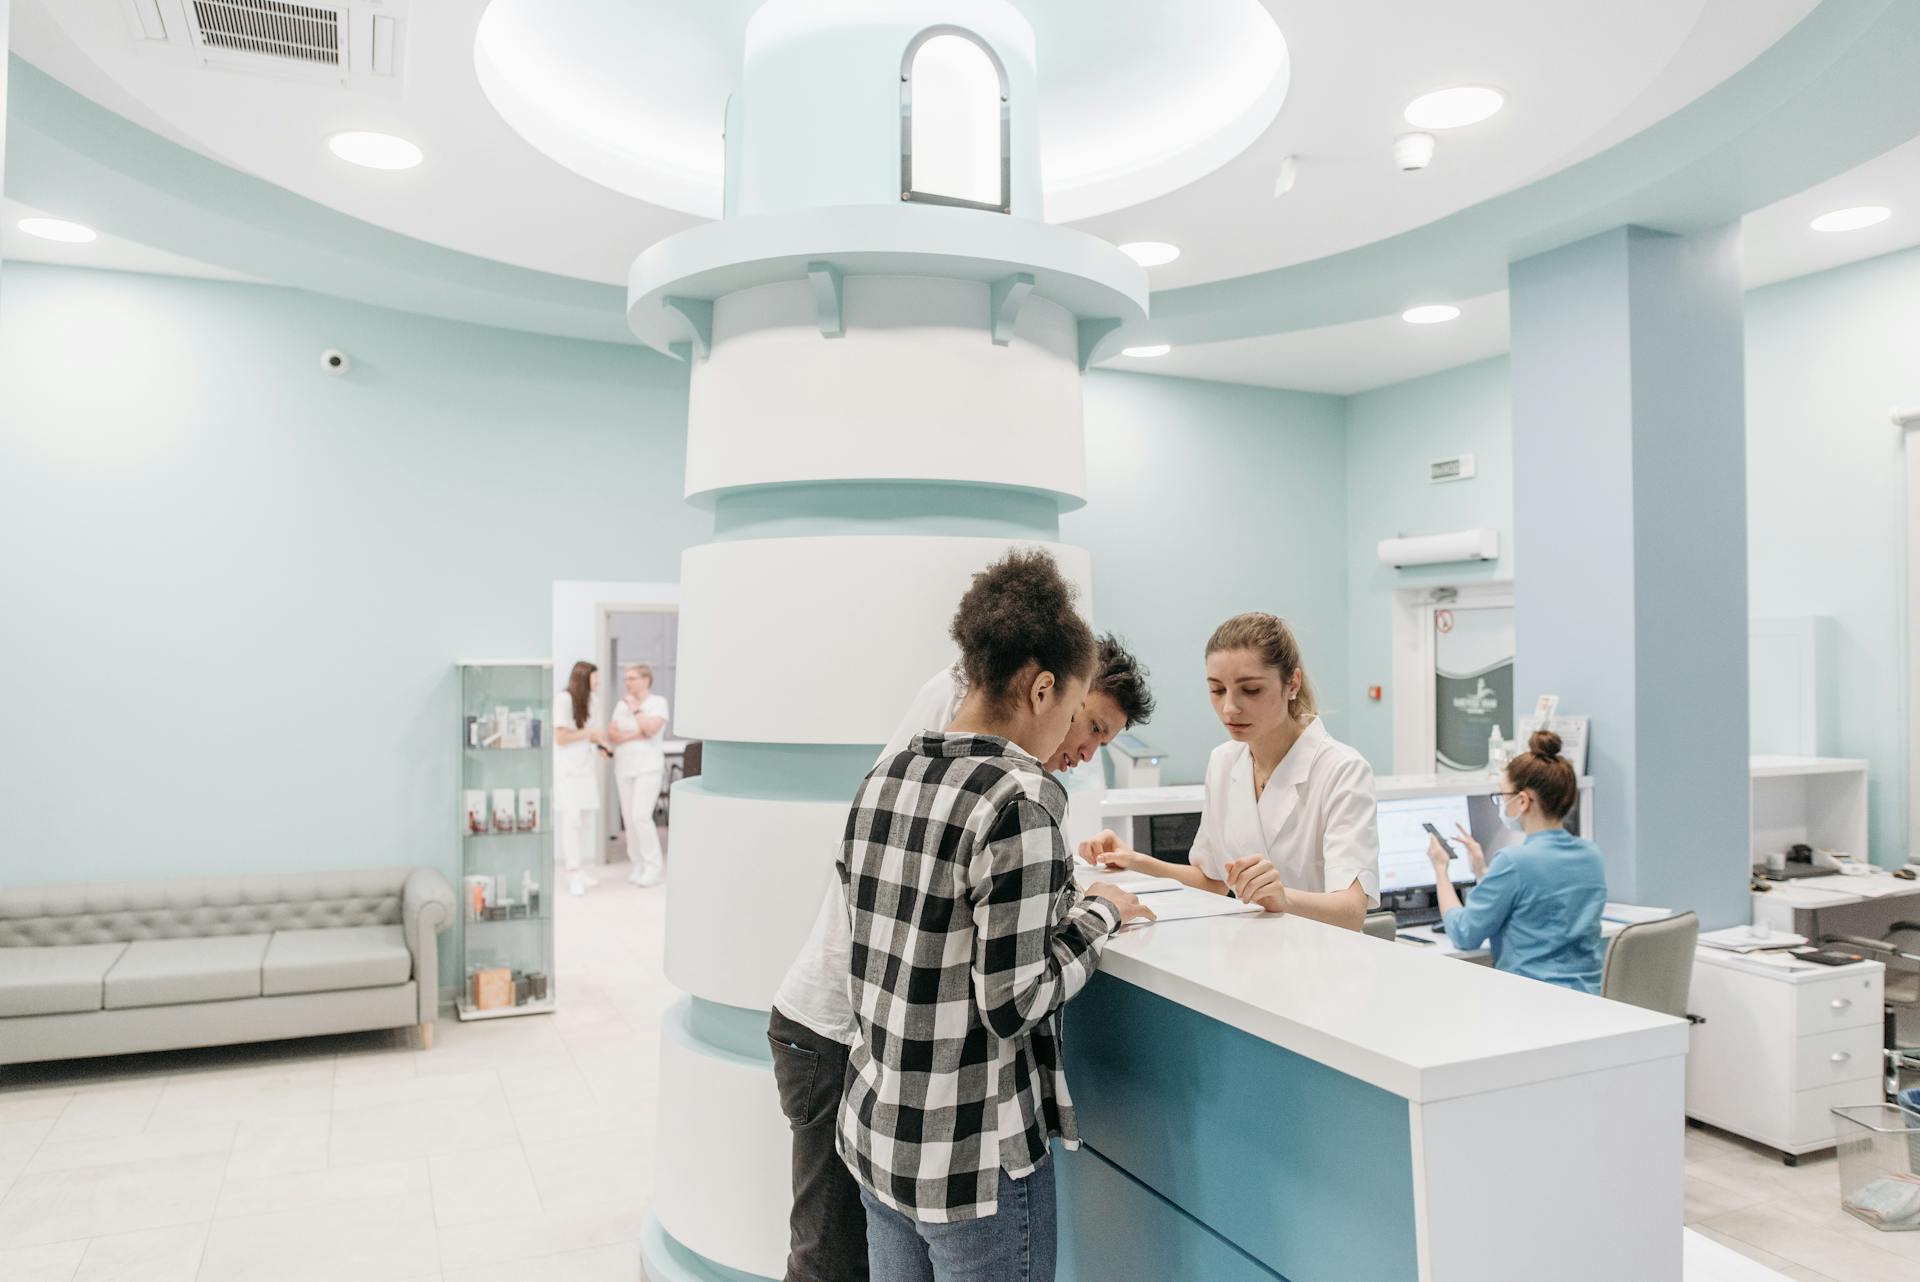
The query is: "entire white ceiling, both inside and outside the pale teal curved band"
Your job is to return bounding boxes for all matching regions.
[15,0,1920,393]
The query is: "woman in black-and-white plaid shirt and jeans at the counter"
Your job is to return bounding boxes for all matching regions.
[837,551,1152,1282]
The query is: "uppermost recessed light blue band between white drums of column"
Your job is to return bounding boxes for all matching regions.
[710,480,1071,543]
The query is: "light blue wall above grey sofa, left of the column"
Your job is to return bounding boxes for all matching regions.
[0,263,710,883]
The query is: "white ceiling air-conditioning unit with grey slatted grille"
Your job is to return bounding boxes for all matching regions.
[121,0,409,94]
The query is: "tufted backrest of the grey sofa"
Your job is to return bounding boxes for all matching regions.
[0,867,413,948]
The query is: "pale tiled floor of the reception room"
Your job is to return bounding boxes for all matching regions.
[0,864,1920,1282]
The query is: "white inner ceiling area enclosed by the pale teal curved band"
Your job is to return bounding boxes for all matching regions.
[13,0,1814,288]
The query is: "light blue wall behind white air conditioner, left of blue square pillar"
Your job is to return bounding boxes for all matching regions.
[1346,357,1513,773]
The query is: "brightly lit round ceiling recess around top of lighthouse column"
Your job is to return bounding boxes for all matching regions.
[474,0,1288,223]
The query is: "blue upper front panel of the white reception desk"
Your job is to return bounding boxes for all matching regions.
[1062,974,1417,1282]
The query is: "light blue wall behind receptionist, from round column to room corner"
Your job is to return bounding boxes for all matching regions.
[1060,370,1359,783]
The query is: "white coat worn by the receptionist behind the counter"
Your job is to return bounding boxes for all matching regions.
[1187,718,1380,908]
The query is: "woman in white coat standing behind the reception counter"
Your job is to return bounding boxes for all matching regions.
[1079,614,1380,931]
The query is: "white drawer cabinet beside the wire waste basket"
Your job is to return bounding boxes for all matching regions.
[1686,948,1884,1161]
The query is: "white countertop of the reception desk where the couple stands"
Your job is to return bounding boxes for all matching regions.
[1100,915,1688,1102]
